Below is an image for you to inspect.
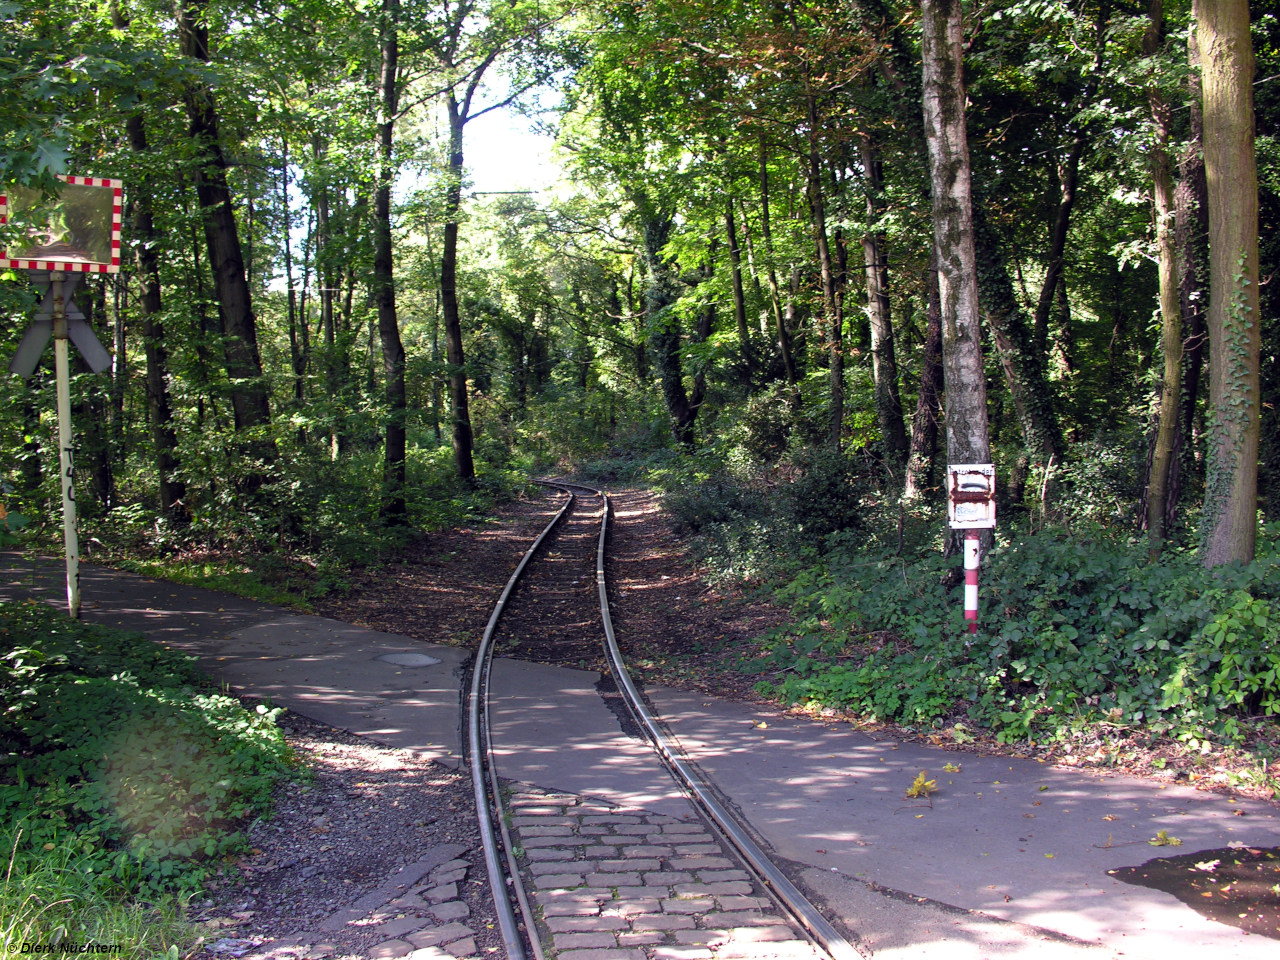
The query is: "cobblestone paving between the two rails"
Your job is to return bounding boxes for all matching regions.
[508,787,822,960]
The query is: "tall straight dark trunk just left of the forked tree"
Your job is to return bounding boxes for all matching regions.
[372,0,408,525]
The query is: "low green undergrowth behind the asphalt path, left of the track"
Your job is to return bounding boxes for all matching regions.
[20,444,532,609]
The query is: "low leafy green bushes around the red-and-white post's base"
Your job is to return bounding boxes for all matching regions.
[744,526,1280,741]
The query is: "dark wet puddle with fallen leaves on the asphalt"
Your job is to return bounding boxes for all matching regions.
[1107,846,1280,940]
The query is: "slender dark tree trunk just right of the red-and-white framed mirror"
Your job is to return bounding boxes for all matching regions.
[124,114,189,524]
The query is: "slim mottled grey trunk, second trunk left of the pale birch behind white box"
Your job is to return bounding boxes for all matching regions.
[860,134,908,484]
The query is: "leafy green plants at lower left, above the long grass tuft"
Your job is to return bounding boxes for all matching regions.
[0,603,293,892]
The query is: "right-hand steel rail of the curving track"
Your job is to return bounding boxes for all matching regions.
[586,484,861,960]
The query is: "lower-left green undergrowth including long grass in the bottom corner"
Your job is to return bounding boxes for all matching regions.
[0,603,296,956]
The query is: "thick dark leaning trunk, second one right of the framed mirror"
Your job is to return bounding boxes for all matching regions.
[175,0,276,481]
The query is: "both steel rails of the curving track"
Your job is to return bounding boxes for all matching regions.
[468,480,861,960]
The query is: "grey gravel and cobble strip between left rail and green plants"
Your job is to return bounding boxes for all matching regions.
[192,714,502,960]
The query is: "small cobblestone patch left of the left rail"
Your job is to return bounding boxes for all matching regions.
[230,846,477,960]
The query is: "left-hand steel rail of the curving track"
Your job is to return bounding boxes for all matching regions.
[467,490,575,960]
